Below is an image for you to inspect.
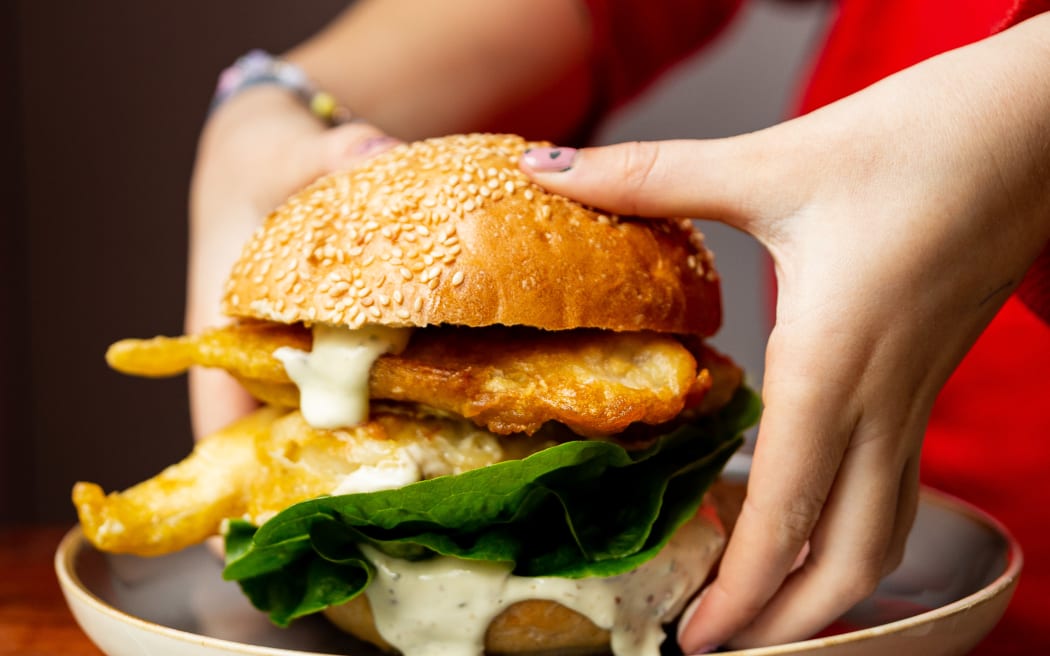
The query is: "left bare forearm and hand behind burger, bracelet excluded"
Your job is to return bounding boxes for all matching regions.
[186,0,591,437]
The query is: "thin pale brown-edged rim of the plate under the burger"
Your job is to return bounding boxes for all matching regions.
[54,486,1024,656]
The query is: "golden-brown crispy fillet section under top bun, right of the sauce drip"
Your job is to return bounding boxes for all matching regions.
[372,327,697,437]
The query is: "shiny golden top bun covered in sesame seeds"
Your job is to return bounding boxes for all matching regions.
[223,134,721,335]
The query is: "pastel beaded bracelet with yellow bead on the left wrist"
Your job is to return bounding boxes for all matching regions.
[211,49,354,125]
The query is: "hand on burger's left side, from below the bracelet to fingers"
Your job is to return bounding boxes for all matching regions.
[186,85,397,438]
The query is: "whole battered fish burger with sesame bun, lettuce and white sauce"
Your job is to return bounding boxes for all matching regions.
[72,134,758,656]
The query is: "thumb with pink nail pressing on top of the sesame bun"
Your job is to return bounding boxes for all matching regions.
[520,134,785,230]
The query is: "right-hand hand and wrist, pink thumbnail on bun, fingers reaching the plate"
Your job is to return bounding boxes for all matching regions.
[523,12,1050,653]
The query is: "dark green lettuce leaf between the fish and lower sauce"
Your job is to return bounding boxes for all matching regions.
[223,388,760,626]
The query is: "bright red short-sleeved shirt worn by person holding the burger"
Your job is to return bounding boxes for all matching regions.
[588,0,1050,655]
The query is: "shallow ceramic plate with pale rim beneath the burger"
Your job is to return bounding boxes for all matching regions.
[55,490,1022,656]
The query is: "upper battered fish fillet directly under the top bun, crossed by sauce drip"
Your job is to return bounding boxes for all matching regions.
[106,322,718,437]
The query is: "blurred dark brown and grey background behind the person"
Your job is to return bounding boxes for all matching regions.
[0,0,824,524]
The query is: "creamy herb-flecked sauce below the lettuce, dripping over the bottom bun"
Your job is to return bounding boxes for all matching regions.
[361,512,721,656]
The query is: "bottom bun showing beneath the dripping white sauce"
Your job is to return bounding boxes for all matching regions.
[324,594,609,656]
